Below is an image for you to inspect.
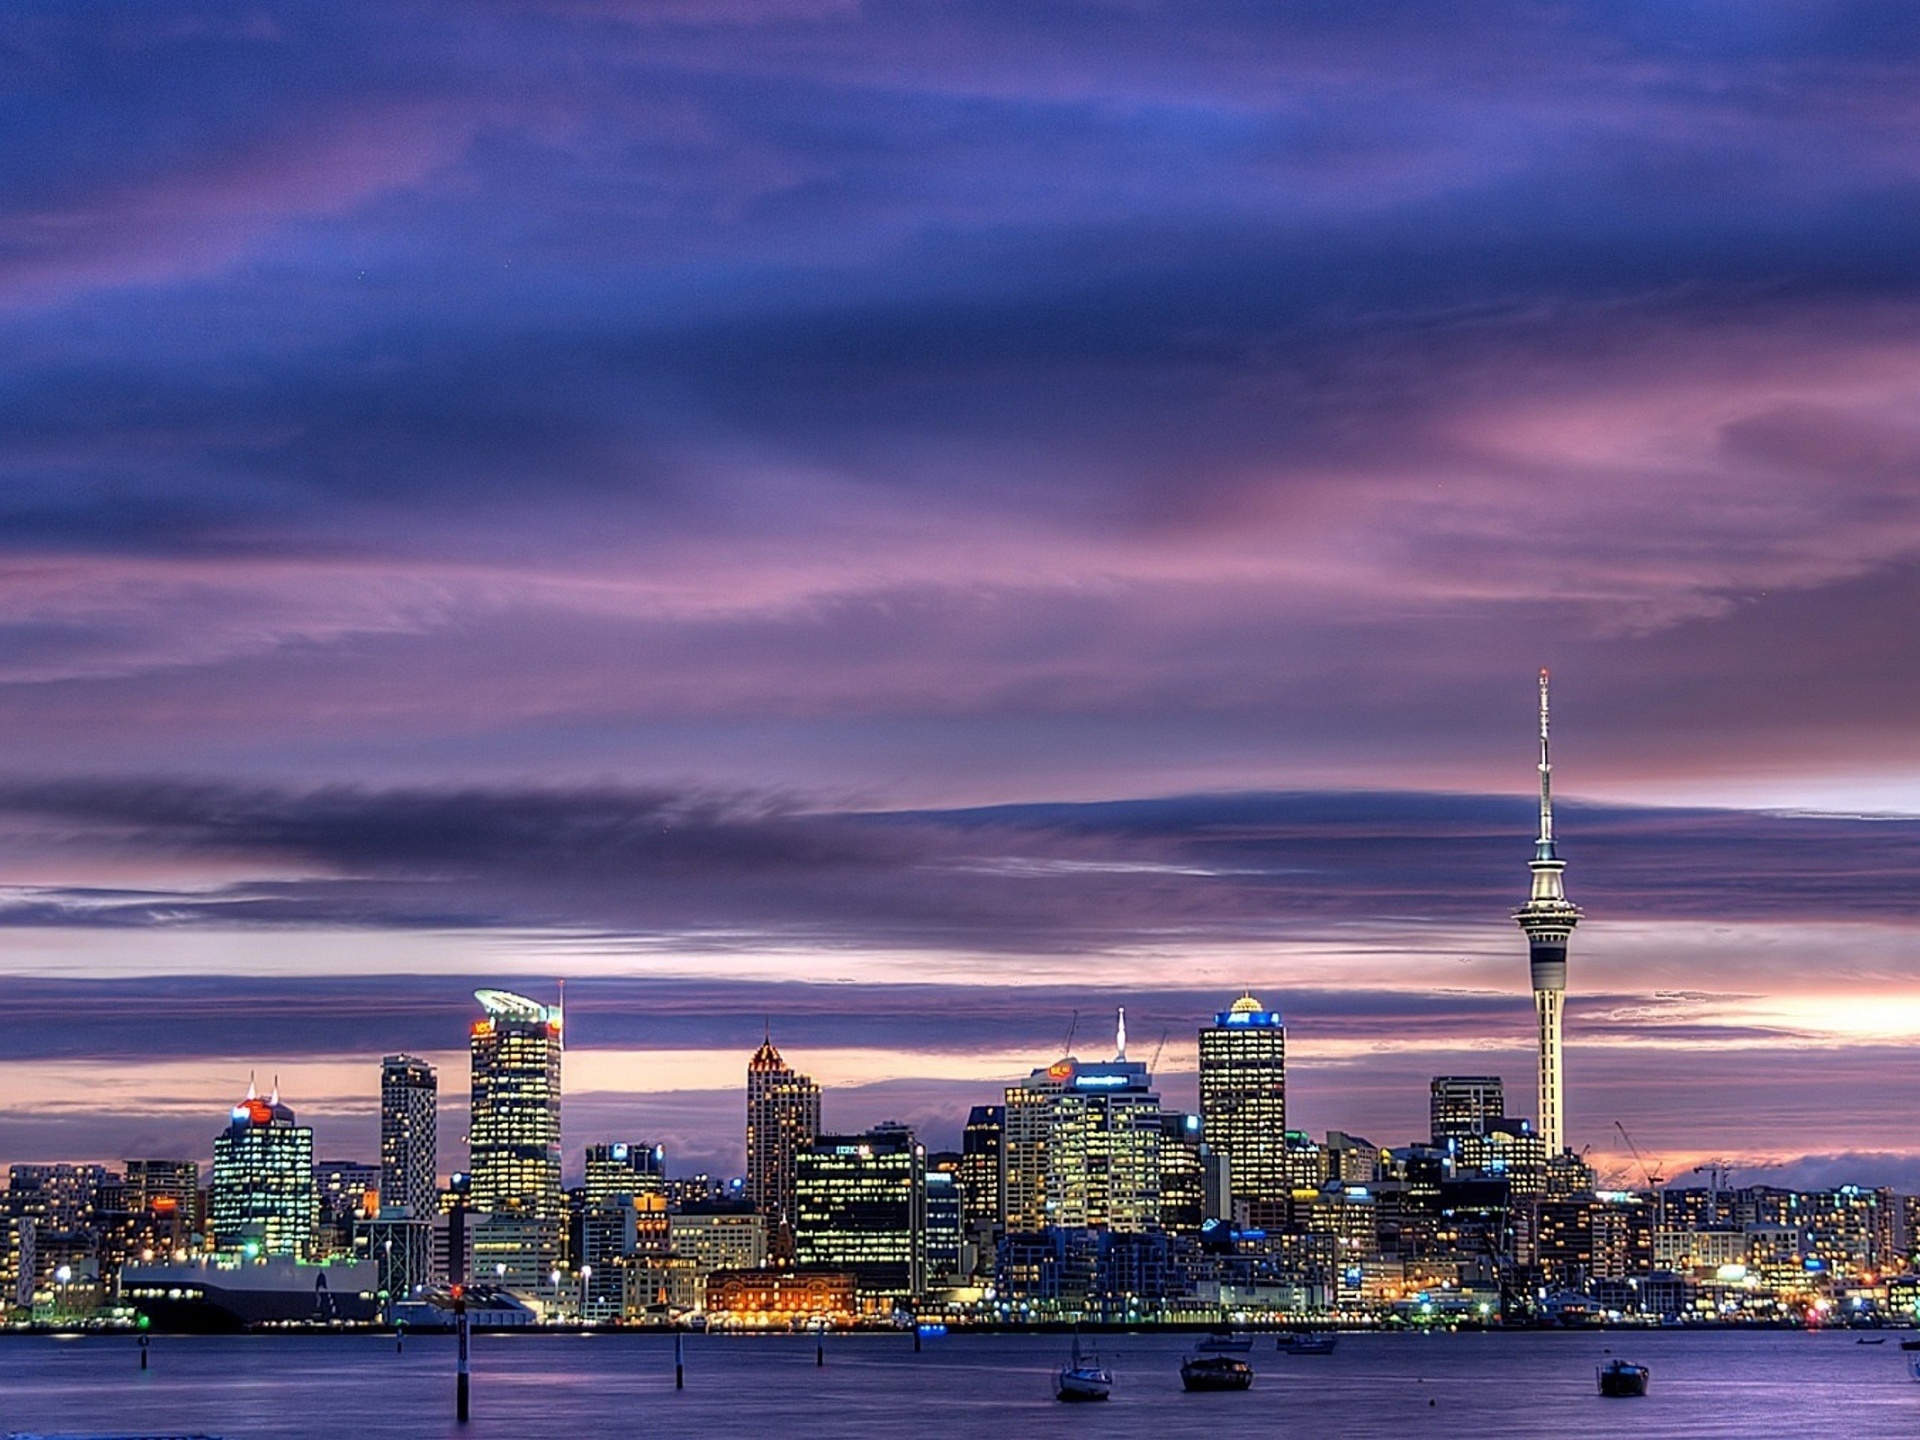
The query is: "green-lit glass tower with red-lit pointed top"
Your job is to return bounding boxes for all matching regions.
[211,1083,321,1260]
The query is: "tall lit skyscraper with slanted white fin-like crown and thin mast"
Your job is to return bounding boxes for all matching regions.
[467,991,566,1286]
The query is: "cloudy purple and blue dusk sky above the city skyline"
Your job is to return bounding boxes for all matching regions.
[0,0,1920,1188]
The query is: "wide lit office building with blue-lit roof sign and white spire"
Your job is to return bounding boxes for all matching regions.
[1004,1029,1162,1233]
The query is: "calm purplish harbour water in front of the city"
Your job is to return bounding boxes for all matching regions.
[0,1331,1920,1440]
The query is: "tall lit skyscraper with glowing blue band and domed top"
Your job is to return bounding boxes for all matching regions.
[1200,995,1288,1202]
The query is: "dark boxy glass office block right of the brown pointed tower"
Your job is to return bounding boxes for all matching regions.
[793,1125,927,1300]
